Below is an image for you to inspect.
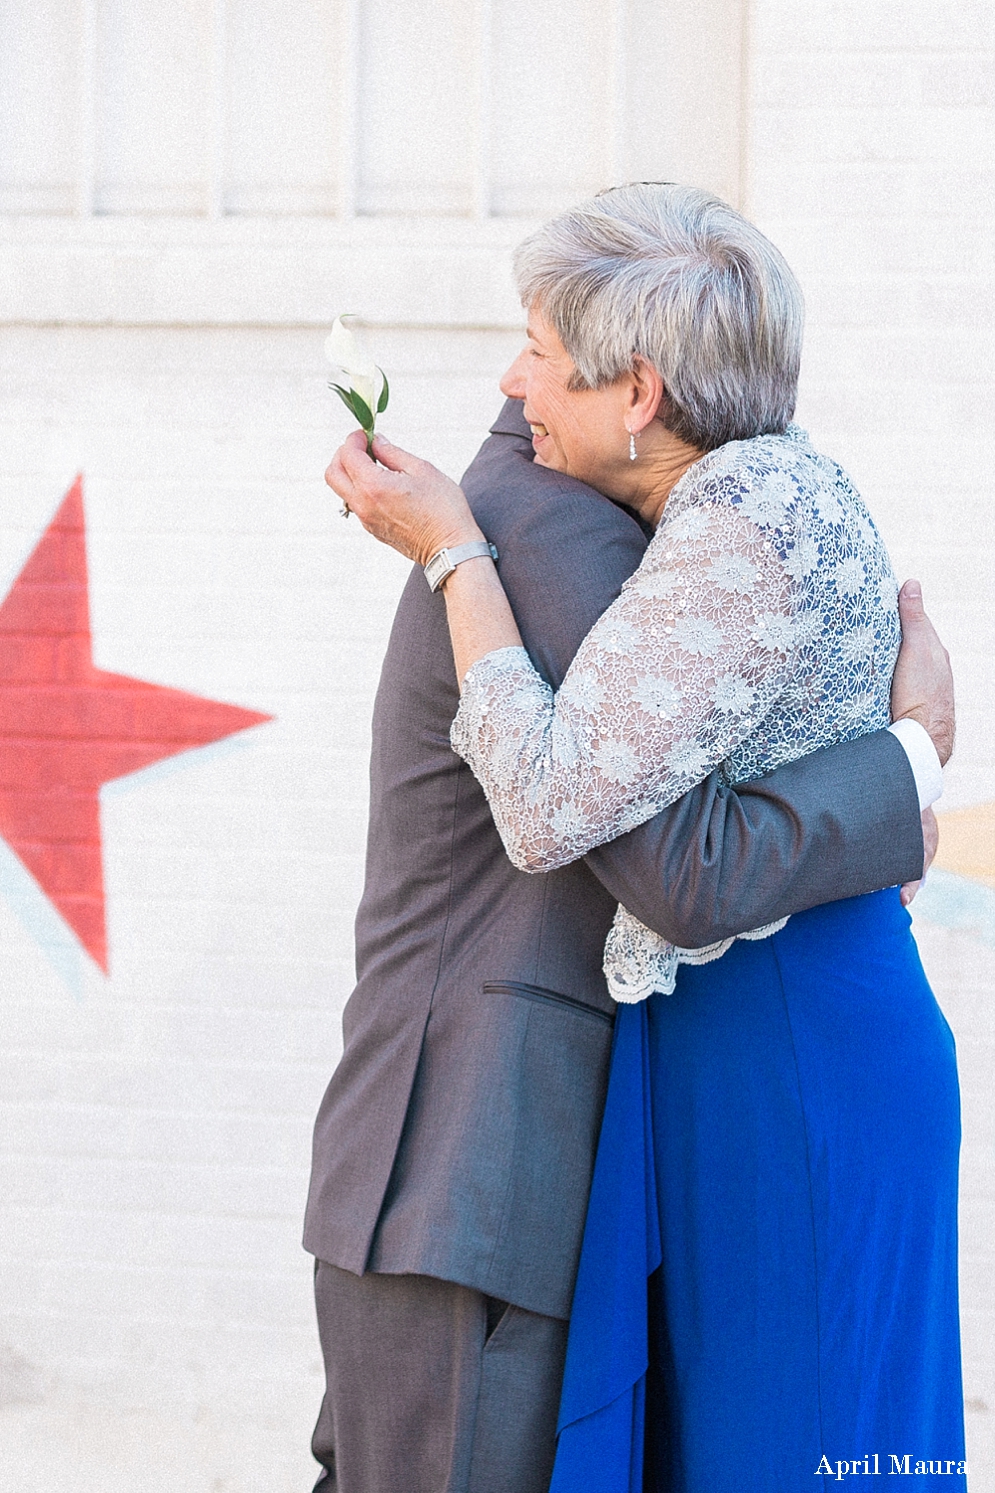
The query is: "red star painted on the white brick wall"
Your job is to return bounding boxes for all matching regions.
[0,476,272,972]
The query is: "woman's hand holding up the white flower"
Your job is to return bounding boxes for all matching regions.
[324,430,484,564]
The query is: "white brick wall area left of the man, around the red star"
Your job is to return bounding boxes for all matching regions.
[0,320,517,1493]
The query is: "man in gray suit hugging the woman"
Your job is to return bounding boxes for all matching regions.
[305,402,949,1493]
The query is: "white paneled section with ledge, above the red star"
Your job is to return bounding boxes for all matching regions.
[0,0,746,325]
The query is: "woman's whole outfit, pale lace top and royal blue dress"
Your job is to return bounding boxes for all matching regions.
[451,426,965,1493]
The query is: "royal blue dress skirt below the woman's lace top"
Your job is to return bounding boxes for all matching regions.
[551,890,967,1493]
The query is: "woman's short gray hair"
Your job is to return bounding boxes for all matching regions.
[514,182,804,451]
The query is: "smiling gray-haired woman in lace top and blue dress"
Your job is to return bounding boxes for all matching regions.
[327,185,965,1493]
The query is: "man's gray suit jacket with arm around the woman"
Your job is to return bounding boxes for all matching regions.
[305,402,922,1317]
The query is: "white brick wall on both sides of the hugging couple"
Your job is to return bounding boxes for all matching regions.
[0,0,995,1493]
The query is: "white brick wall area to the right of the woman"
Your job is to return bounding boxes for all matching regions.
[747,0,995,1493]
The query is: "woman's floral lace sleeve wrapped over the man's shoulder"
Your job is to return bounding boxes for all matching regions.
[451,502,798,870]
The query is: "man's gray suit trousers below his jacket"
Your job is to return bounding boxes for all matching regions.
[311,1260,568,1493]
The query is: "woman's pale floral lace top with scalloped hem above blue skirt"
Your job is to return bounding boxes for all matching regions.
[451,426,901,1000]
